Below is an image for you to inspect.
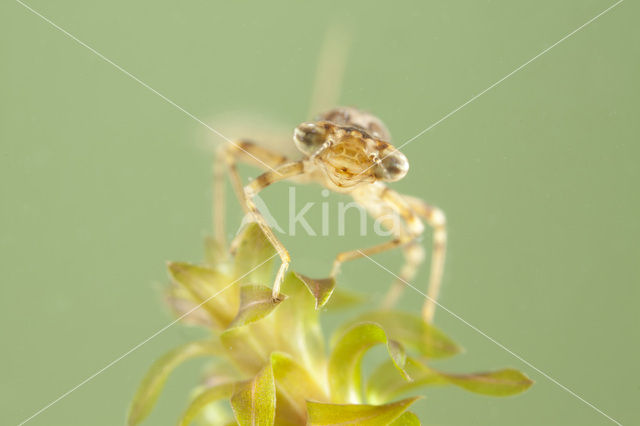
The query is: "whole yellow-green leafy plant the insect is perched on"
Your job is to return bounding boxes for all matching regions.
[128,224,532,425]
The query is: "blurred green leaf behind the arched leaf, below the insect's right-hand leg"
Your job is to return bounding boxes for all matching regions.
[336,311,460,358]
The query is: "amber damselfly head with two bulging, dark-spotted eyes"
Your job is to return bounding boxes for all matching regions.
[294,108,409,187]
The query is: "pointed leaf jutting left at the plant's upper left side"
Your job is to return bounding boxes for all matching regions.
[169,262,239,328]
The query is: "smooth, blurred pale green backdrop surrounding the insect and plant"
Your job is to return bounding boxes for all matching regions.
[0,0,640,426]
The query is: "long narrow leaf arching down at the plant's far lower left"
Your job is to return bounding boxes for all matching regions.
[127,340,220,426]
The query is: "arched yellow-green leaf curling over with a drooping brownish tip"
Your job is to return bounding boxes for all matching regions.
[328,322,408,403]
